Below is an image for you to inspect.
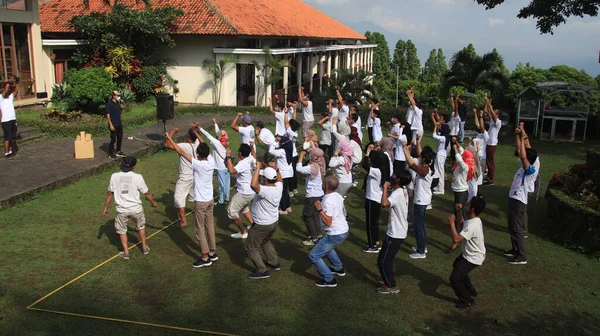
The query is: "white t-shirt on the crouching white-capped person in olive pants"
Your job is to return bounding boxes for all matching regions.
[252,182,283,225]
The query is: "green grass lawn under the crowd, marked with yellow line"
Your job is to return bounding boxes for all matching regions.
[0,126,600,335]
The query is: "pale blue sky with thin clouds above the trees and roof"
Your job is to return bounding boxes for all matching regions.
[304,0,600,77]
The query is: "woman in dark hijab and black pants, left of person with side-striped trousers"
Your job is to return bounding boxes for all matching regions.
[363,145,390,253]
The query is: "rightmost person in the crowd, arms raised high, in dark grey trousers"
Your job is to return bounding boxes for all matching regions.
[506,125,539,265]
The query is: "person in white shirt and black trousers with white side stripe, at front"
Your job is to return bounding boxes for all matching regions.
[377,170,412,294]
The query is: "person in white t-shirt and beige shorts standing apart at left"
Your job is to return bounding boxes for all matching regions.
[102,156,158,260]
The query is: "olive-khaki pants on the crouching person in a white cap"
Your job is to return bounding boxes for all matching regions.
[246,222,279,273]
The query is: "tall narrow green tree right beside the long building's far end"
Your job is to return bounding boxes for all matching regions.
[365,31,396,104]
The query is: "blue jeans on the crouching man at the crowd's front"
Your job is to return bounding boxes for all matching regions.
[308,232,348,282]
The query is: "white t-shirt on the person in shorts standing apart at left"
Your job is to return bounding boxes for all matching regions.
[108,172,148,213]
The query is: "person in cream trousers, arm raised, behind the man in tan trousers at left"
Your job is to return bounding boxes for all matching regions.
[164,125,200,227]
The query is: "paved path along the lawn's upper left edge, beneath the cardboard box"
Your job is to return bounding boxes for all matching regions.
[0,114,273,210]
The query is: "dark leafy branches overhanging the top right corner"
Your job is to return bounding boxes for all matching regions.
[475,0,600,34]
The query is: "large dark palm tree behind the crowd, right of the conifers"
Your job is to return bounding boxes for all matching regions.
[444,45,507,94]
